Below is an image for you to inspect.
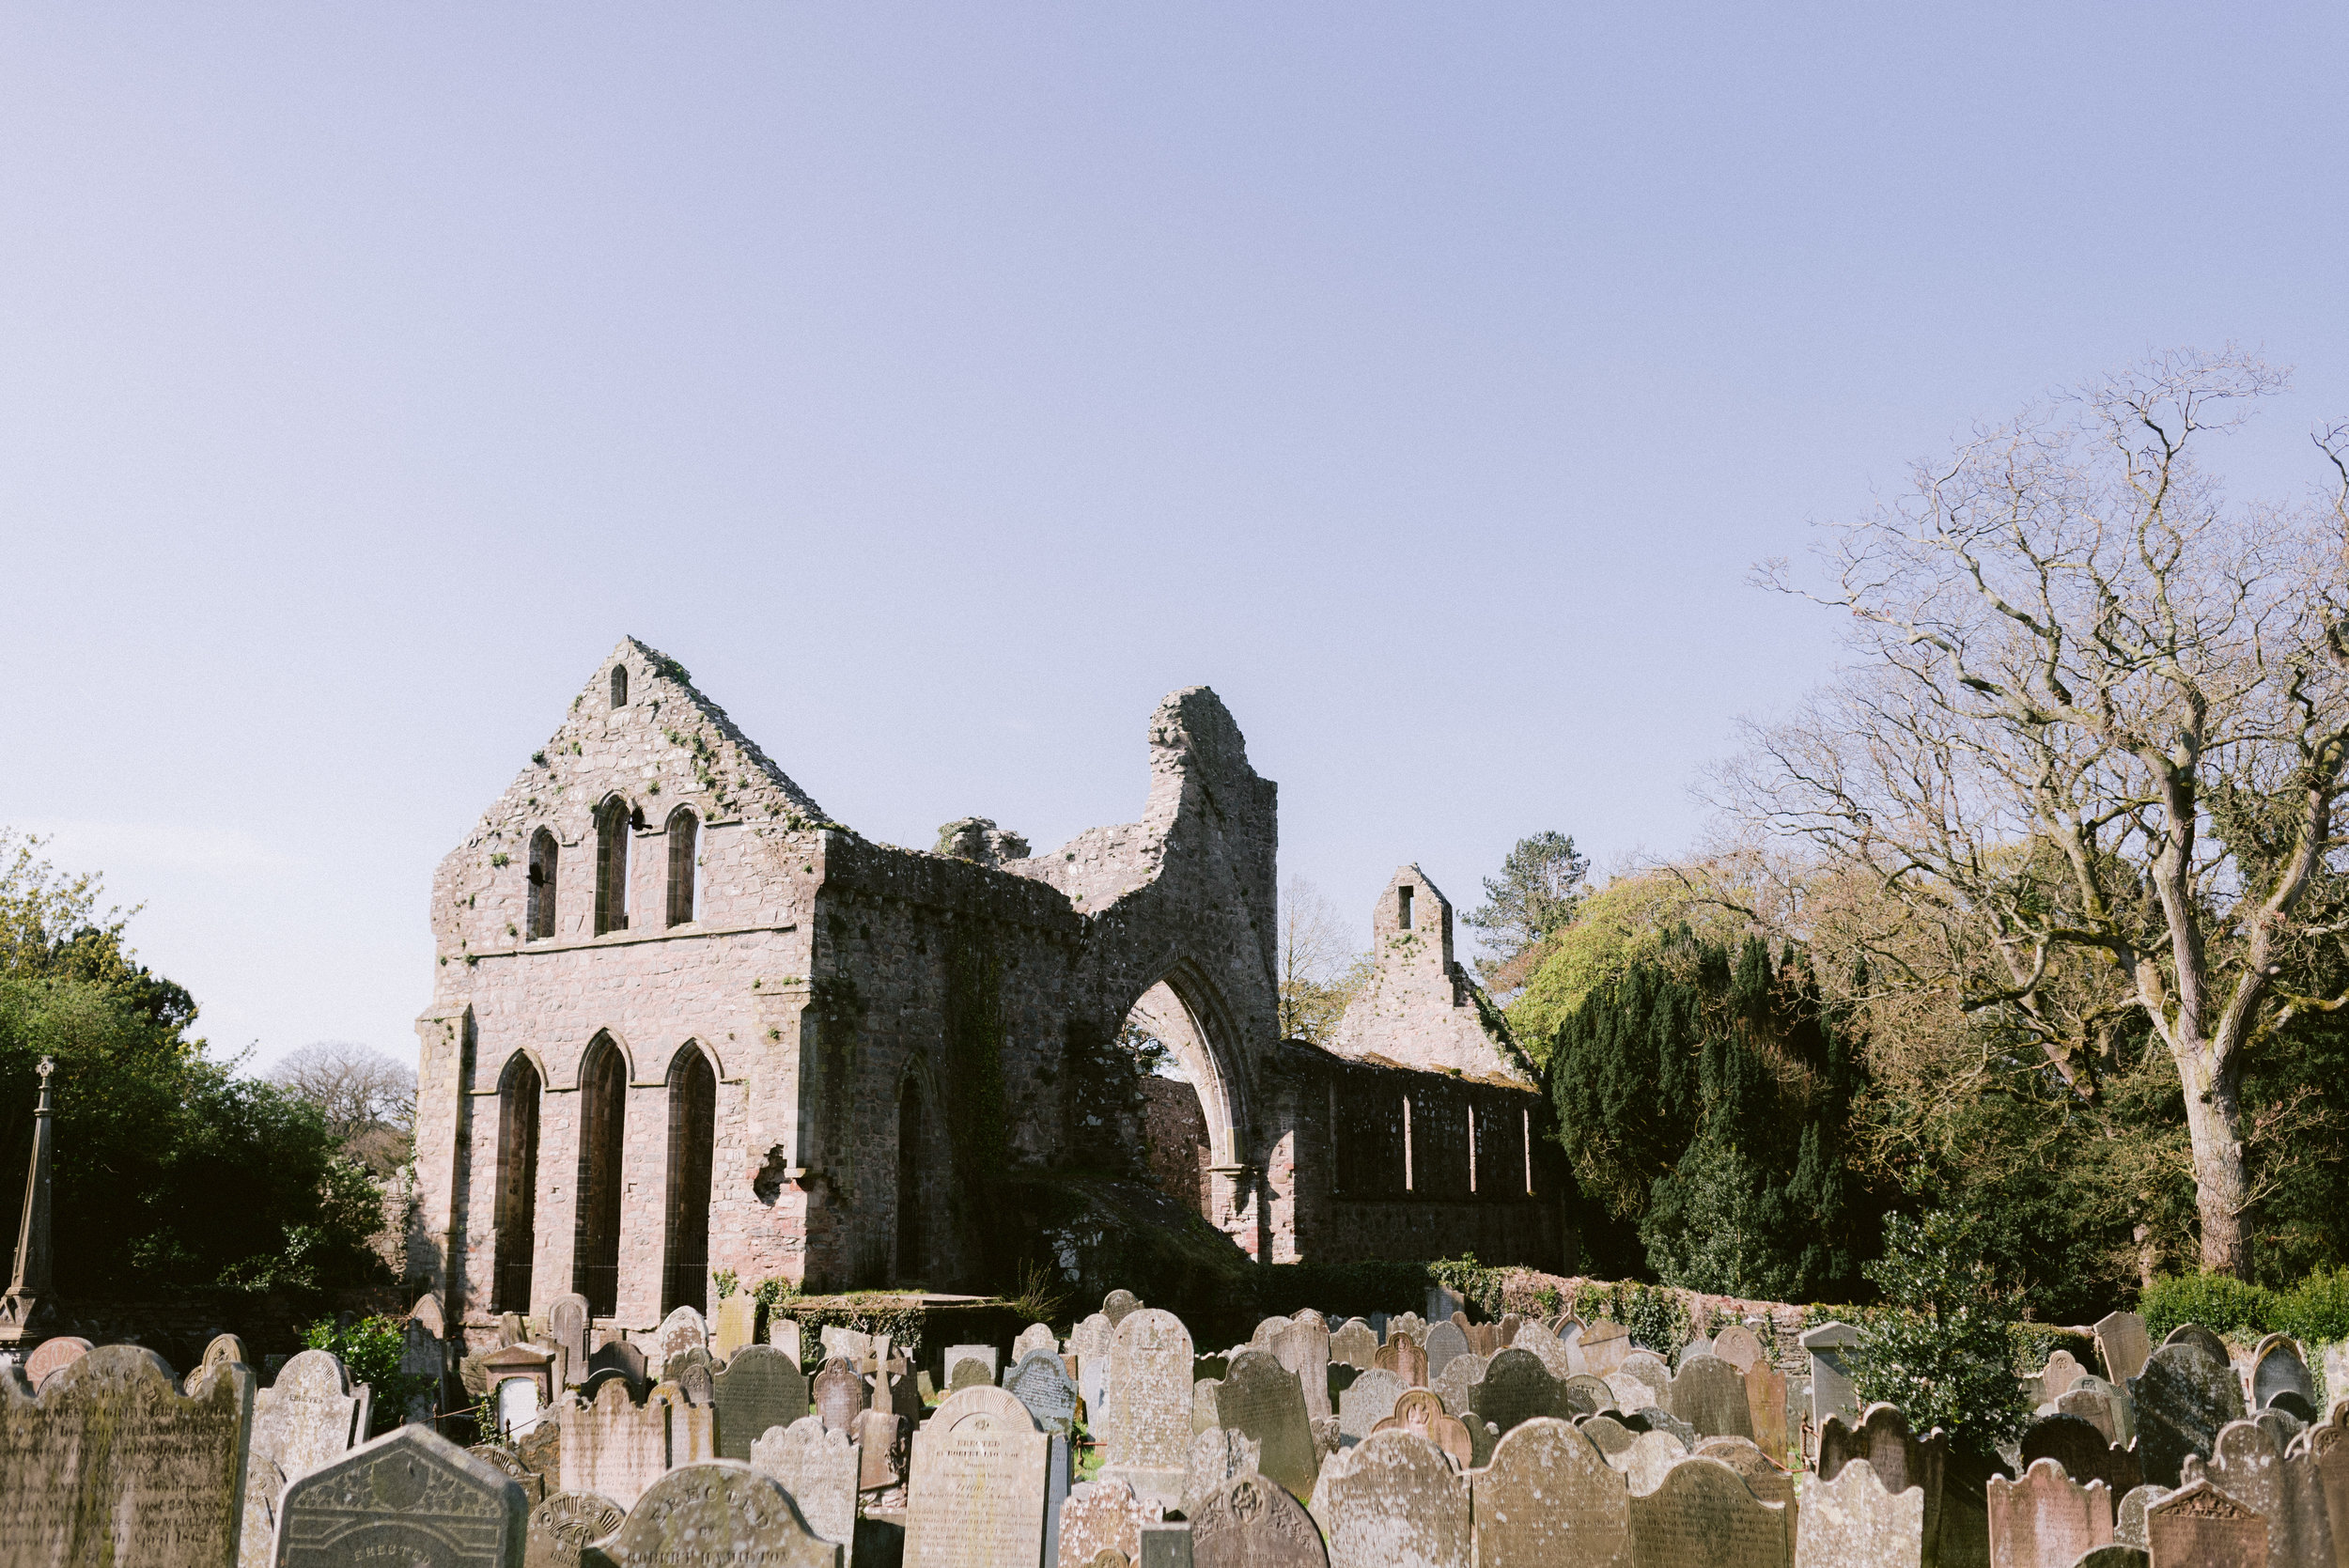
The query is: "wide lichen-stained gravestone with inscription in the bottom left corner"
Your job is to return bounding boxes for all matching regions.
[0,1345,254,1568]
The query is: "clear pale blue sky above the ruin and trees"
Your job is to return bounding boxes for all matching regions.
[0,0,2349,1061]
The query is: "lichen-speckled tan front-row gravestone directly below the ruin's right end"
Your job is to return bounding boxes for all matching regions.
[1470,1418,1630,1568]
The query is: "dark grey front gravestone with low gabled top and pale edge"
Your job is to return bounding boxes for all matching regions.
[277,1427,531,1568]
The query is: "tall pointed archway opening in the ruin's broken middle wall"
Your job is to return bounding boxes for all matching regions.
[1118,970,1236,1223]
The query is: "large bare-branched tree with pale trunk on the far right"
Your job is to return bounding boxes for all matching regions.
[1724,349,2349,1275]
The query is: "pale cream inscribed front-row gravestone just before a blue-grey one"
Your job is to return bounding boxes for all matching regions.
[905,1388,1052,1568]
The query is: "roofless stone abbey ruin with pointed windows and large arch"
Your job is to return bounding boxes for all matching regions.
[409,639,1569,1331]
